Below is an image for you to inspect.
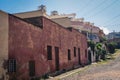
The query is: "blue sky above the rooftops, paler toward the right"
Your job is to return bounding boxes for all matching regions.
[0,0,120,34]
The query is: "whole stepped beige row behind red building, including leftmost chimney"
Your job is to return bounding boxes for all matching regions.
[14,5,105,43]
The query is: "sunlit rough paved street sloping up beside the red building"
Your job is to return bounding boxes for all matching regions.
[49,49,120,80]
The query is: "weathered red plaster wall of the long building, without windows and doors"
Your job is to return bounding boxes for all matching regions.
[9,15,87,79]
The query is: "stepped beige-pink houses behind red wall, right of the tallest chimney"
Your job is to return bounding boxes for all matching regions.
[51,13,105,43]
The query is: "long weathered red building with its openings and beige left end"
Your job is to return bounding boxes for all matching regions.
[0,11,88,80]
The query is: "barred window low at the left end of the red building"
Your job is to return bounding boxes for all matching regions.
[8,59,16,72]
